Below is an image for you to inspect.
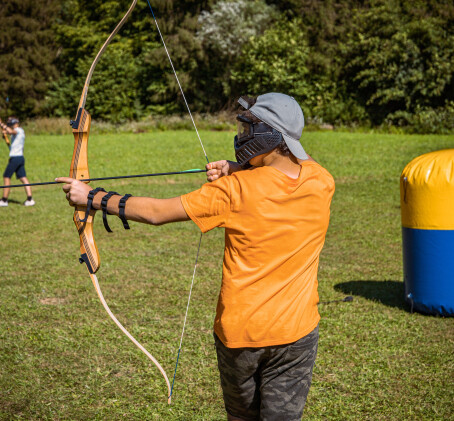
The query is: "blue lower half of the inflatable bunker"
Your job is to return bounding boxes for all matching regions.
[402,227,454,316]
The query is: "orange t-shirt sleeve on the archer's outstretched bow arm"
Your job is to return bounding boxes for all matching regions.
[181,176,231,233]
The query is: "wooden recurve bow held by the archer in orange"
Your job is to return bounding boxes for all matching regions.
[69,0,171,404]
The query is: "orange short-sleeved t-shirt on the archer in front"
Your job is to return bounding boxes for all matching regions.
[181,161,334,348]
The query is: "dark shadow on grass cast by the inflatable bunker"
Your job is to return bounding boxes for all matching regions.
[334,280,409,311]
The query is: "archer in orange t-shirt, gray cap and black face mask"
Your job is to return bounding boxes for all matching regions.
[56,93,334,421]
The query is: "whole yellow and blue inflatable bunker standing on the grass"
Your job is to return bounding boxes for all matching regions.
[400,149,454,316]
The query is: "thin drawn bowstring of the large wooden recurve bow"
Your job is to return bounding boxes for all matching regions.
[147,0,210,401]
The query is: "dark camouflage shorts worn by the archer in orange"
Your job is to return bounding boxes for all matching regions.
[214,326,318,421]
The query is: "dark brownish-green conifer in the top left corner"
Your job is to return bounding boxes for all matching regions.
[0,0,60,118]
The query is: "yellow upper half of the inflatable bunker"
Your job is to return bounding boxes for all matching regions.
[400,149,454,230]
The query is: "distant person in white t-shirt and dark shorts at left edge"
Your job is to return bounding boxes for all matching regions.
[0,117,35,207]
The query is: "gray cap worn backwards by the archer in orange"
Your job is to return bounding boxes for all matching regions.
[245,92,309,159]
